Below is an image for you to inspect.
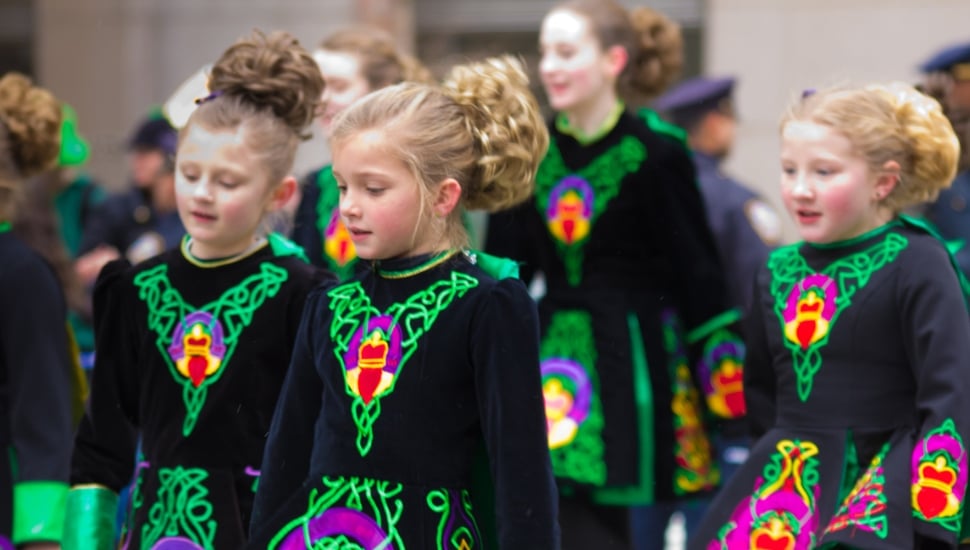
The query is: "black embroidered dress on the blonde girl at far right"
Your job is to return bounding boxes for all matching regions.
[690,221,970,550]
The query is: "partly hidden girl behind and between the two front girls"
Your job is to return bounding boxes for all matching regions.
[292,27,431,279]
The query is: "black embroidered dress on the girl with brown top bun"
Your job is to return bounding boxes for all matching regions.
[71,236,332,550]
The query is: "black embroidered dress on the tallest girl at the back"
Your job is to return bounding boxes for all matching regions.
[486,113,744,505]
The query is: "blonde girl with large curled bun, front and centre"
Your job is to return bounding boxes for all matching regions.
[251,58,558,550]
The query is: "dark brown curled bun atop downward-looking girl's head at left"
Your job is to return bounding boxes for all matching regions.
[209,30,323,138]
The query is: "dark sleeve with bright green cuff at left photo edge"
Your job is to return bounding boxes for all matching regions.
[0,257,73,544]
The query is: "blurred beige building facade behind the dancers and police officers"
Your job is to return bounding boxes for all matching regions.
[11,0,970,239]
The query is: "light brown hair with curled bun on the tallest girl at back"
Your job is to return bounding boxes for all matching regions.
[553,0,684,104]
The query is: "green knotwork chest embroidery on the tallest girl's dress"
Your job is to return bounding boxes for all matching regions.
[535,136,647,286]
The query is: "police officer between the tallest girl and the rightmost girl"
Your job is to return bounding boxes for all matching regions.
[653,77,781,311]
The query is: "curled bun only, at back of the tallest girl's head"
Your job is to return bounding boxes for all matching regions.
[629,7,684,99]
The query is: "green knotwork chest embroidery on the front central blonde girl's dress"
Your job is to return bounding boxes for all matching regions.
[328,272,478,456]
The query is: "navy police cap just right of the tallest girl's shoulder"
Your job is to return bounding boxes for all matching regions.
[653,76,735,129]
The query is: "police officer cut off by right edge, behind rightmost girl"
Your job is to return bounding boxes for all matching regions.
[920,42,970,276]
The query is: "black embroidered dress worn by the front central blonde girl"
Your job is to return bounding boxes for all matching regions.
[250,252,558,550]
